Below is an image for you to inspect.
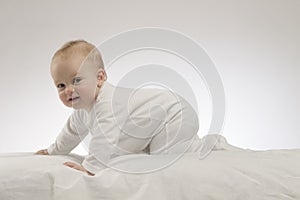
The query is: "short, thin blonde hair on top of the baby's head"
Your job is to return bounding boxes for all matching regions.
[51,40,104,69]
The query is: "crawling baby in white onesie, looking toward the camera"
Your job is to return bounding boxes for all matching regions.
[36,40,199,175]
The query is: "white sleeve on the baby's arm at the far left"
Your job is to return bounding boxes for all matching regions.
[47,111,88,155]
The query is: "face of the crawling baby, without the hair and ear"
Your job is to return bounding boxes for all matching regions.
[51,55,99,111]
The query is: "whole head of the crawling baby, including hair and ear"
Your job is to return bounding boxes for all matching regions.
[50,40,106,111]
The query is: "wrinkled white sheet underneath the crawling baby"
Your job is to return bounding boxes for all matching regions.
[0,135,300,200]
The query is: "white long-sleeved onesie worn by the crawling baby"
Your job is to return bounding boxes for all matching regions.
[48,81,199,174]
